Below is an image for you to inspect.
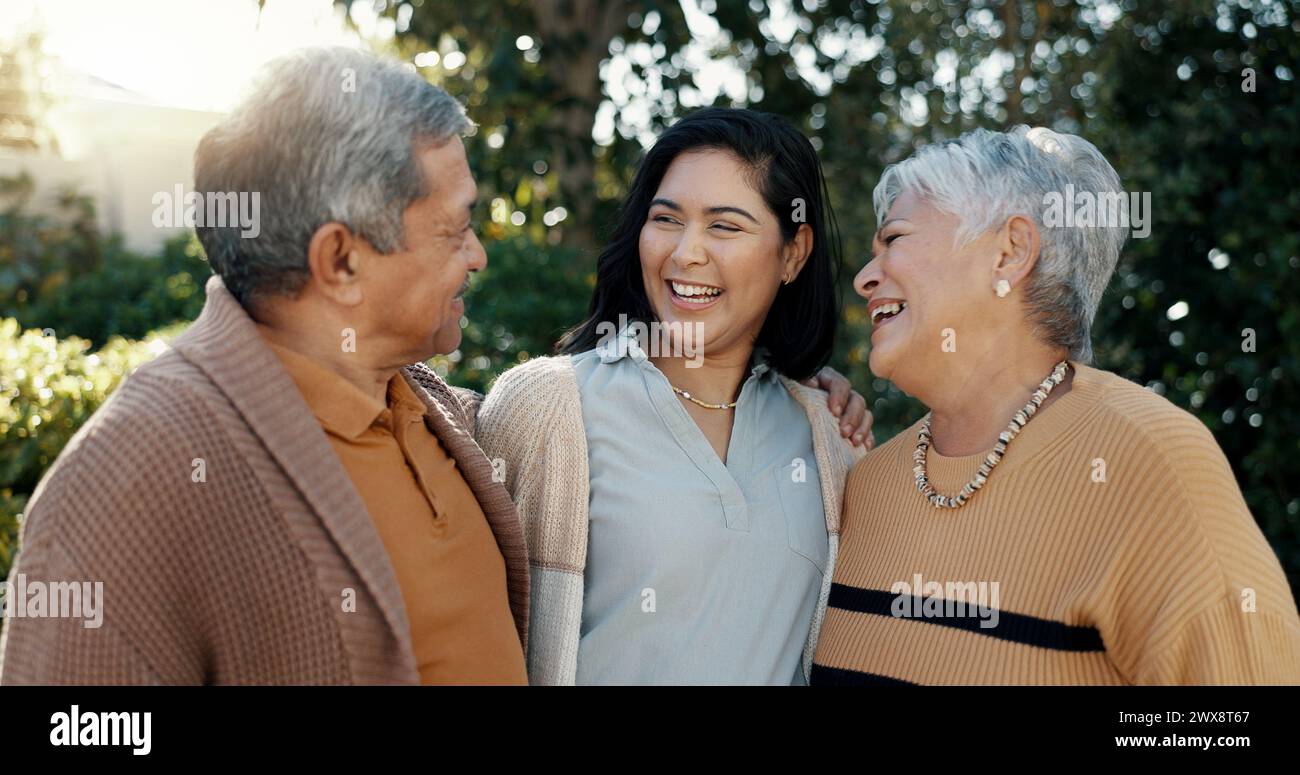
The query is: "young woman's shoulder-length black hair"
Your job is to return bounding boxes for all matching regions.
[556,108,841,380]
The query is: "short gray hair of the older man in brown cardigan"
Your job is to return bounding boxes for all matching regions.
[194,48,473,306]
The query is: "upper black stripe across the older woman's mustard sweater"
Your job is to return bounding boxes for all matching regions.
[827,584,1106,651]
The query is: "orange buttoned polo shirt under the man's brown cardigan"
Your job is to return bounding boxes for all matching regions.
[259,326,528,685]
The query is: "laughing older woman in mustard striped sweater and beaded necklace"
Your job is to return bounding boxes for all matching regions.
[813,127,1300,684]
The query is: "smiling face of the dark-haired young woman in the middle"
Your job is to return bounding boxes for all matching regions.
[640,150,811,358]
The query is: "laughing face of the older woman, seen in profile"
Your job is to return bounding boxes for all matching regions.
[853,191,998,394]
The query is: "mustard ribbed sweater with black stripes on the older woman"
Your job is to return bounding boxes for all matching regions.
[813,364,1300,684]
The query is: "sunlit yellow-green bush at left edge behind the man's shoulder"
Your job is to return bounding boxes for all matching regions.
[0,319,185,577]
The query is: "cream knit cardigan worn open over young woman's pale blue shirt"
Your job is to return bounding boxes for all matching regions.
[476,355,865,685]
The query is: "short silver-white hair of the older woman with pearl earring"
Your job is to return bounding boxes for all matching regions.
[872,126,1128,363]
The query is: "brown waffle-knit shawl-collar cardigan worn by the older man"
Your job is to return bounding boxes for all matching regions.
[0,277,529,684]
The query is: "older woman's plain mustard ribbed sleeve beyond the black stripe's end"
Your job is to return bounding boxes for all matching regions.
[1102,400,1300,684]
